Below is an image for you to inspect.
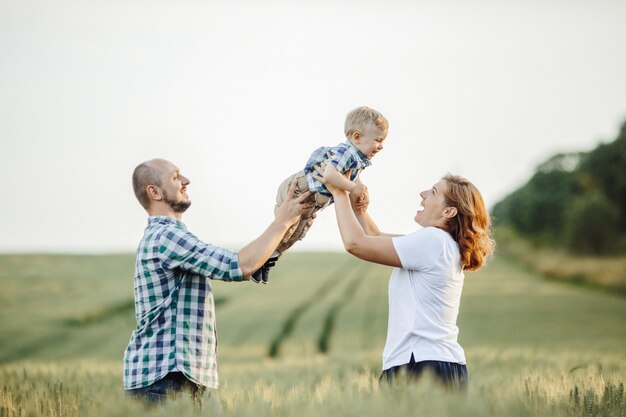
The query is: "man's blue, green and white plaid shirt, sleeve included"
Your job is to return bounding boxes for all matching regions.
[124,216,243,389]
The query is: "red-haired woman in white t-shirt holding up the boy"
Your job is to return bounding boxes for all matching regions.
[319,166,494,389]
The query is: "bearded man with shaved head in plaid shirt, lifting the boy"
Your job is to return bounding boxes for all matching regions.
[124,159,311,405]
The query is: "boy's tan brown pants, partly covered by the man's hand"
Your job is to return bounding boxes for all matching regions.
[276,171,330,256]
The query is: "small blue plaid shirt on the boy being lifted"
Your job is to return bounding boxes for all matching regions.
[304,141,372,198]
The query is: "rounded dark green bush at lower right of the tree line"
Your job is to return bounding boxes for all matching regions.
[565,192,620,255]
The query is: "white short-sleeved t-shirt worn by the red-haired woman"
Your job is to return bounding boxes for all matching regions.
[383,227,465,370]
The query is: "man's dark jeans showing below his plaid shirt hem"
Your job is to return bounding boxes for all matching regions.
[126,372,206,408]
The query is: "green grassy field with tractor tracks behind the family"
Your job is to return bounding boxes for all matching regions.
[0,253,626,417]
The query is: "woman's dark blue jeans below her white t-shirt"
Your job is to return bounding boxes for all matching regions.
[379,354,468,391]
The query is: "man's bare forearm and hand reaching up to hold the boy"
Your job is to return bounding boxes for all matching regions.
[238,181,313,280]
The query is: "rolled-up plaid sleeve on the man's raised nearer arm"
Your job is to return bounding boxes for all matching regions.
[159,227,243,281]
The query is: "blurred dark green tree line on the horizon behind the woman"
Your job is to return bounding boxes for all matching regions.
[492,121,626,255]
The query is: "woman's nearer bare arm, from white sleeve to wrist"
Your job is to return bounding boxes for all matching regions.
[330,188,402,268]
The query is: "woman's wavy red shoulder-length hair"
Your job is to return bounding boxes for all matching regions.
[443,174,495,271]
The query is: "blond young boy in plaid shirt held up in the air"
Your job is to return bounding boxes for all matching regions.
[252,107,382,283]
